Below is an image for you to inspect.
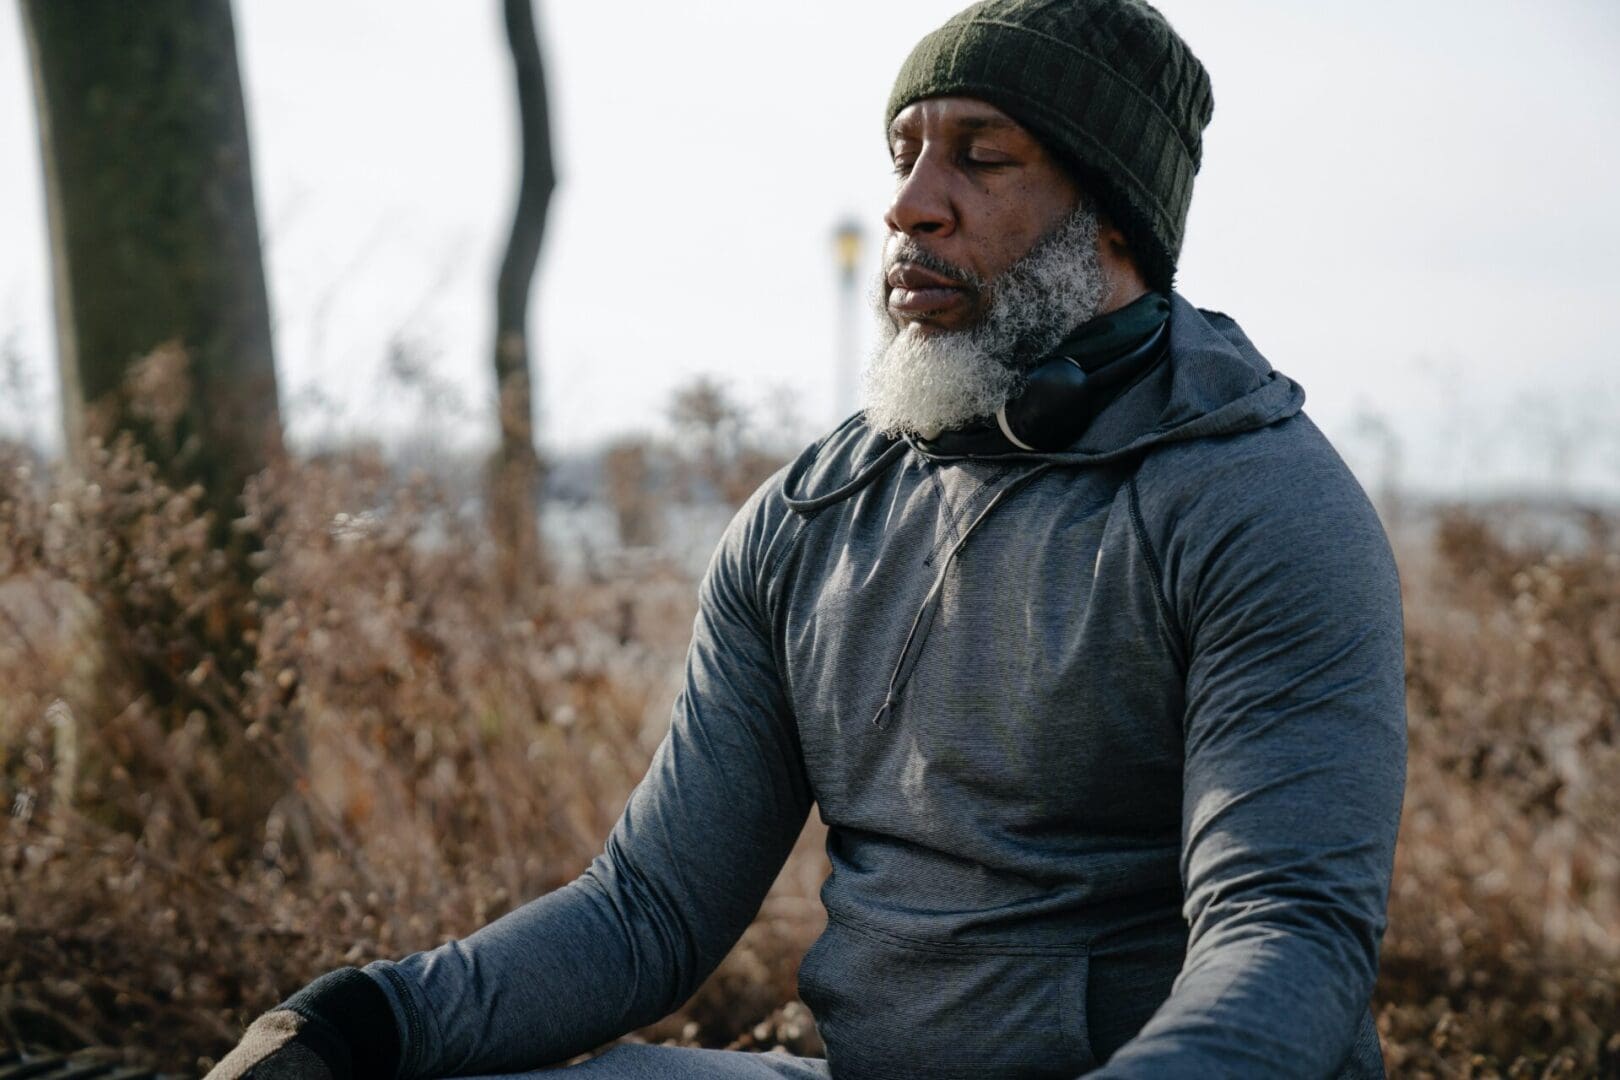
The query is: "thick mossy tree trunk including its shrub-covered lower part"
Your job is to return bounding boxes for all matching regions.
[21,0,282,853]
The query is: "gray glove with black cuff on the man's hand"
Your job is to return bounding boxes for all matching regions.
[204,968,399,1080]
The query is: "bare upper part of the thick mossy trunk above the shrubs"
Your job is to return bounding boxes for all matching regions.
[21,0,280,524]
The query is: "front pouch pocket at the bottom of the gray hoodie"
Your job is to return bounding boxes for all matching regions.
[799,916,1097,1080]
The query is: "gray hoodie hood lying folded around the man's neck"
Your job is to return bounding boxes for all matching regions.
[782,293,1306,513]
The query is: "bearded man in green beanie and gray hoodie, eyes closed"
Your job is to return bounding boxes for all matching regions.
[217,0,1405,1080]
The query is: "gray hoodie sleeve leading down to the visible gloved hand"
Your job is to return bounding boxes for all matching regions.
[366,500,810,1080]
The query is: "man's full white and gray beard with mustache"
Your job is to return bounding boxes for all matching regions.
[862,207,1106,437]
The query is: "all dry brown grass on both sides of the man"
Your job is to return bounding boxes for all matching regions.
[0,447,1620,1077]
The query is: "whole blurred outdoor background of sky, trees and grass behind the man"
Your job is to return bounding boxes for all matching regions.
[0,0,1620,1077]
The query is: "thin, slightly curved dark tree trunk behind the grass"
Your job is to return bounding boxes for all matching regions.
[489,0,557,585]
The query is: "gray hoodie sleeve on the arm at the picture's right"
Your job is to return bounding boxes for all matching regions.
[1095,416,1406,1078]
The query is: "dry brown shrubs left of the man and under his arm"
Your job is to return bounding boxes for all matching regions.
[0,444,821,1074]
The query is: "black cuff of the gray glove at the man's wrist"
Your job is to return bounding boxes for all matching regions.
[280,968,400,1080]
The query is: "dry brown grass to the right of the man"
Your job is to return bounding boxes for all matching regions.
[1379,513,1620,1077]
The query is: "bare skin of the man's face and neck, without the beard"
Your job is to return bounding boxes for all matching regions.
[883,97,1147,332]
